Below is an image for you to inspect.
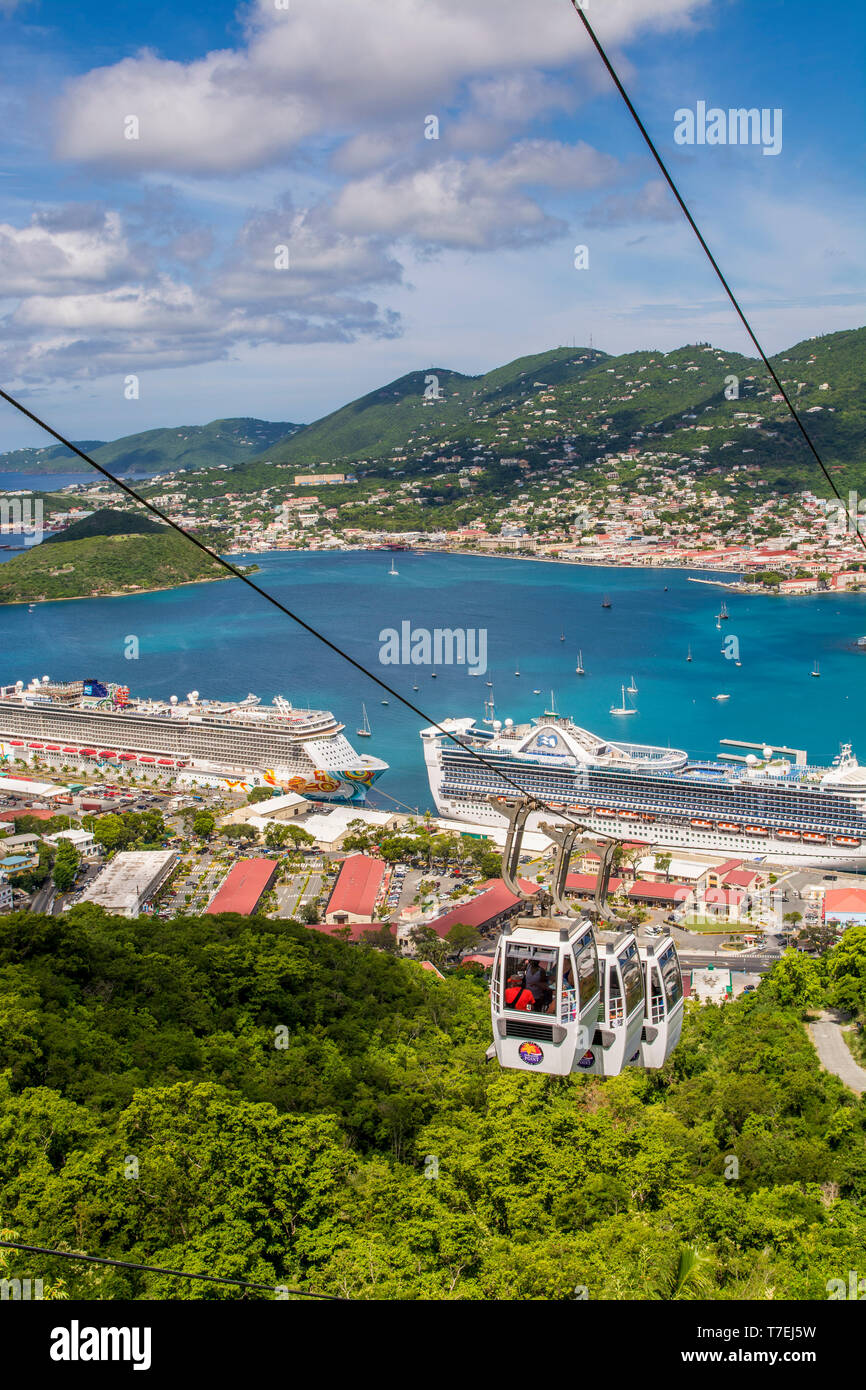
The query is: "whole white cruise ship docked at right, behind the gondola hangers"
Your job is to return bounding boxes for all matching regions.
[421,712,866,870]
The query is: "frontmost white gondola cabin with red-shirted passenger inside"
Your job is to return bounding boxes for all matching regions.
[491,917,601,1076]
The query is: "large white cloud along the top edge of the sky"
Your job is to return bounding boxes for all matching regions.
[57,0,708,174]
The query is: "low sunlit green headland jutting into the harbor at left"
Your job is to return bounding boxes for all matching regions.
[0,531,232,603]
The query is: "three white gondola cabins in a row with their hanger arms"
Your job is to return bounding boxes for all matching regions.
[488,796,685,1076]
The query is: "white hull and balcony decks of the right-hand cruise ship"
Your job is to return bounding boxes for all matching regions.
[421,720,866,870]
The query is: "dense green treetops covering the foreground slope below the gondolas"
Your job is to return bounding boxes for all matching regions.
[0,906,866,1300]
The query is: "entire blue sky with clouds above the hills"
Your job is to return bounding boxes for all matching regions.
[0,0,866,449]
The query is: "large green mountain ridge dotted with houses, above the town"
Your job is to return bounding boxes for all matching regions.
[240,328,866,493]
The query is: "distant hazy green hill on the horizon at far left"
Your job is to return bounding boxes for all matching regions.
[0,418,300,474]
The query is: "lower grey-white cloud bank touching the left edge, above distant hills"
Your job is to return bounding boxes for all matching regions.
[0,195,402,379]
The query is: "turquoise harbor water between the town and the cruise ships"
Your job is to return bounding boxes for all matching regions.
[0,552,866,808]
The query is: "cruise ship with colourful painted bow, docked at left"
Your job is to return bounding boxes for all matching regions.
[0,676,388,805]
